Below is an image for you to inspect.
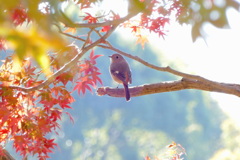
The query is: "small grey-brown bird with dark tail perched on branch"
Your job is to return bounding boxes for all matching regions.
[109,53,132,101]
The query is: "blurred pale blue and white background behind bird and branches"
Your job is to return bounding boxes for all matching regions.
[5,0,240,160]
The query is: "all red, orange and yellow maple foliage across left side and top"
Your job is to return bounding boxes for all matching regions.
[0,0,236,159]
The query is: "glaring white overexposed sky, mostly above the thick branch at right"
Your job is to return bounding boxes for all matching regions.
[98,0,240,127]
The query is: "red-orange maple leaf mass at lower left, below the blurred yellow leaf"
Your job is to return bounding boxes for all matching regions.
[0,46,102,159]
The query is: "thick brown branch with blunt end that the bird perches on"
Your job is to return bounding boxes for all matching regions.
[97,78,240,97]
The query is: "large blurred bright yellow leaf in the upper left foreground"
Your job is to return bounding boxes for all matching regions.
[3,25,66,75]
